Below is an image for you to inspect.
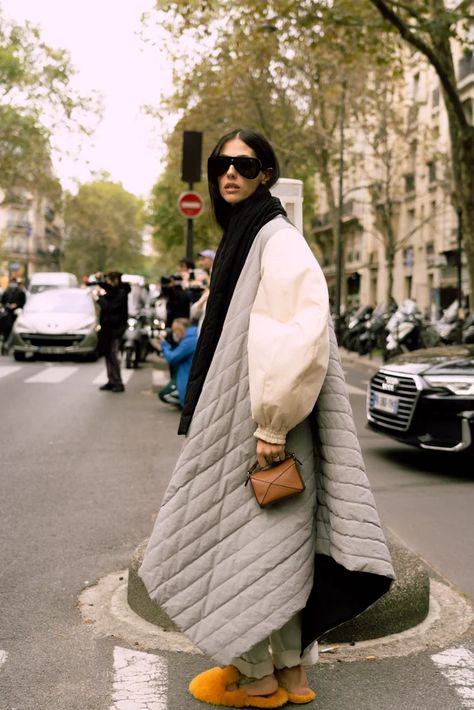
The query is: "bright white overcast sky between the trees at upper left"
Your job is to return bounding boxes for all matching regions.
[0,0,175,197]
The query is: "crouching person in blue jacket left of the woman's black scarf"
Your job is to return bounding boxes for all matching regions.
[159,318,198,408]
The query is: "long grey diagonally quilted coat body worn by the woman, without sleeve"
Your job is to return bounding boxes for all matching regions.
[140,218,394,664]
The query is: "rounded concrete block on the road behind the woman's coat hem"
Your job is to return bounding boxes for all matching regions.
[127,537,430,643]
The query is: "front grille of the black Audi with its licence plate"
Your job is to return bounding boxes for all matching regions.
[369,372,418,431]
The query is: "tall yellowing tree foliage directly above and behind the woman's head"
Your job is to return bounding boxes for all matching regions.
[145,0,396,264]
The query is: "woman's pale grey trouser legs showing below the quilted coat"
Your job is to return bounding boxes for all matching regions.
[232,614,318,678]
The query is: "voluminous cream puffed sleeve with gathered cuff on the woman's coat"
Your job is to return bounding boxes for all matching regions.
[248,225,329,444]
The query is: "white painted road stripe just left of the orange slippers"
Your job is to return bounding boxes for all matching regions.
[109,646,168,710]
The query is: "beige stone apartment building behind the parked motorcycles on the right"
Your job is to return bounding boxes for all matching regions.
[312,40,474,317]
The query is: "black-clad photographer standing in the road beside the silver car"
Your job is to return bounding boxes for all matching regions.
[97,271,130,392]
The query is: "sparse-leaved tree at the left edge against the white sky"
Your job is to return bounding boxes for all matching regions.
[0,10,95,200]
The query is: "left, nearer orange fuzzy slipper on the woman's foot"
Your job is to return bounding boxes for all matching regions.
[189,666,288,708]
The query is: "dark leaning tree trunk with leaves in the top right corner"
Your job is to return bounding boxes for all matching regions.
[370,0,474,304]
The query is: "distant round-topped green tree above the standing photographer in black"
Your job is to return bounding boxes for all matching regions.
[65,179,144,276]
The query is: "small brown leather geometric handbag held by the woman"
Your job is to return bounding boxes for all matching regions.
[245,454,305,508]
